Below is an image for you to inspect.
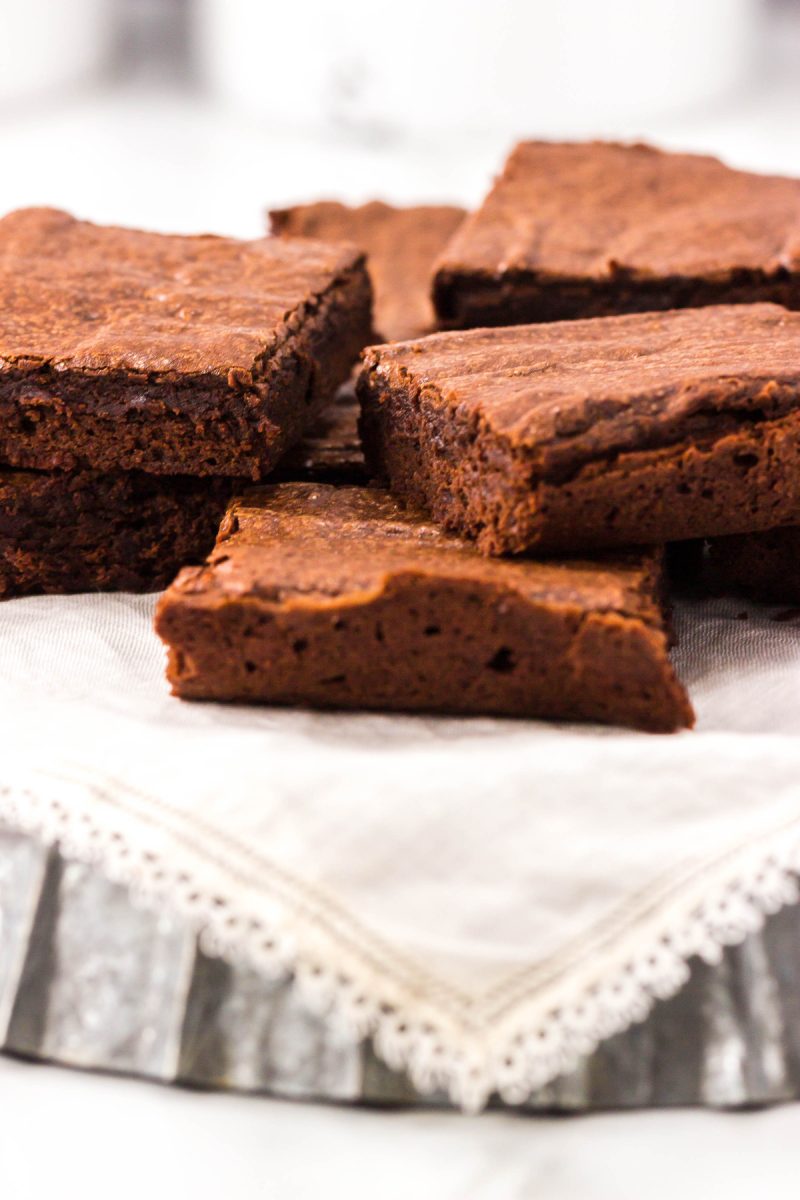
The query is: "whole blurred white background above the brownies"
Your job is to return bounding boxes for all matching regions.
[0,0,800,235]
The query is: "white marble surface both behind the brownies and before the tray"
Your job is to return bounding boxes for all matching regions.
[0,72,800,1200]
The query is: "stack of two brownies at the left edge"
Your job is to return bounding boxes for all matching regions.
[0,209,371,596]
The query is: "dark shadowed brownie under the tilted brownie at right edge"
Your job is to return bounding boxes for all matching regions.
[670,526,800,605]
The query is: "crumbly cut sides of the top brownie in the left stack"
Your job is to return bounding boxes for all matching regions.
[0,252,372,479]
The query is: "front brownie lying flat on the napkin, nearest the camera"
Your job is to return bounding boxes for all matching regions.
[156,484,693,731]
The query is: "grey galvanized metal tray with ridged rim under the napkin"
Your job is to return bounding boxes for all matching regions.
[0,828,800,1111]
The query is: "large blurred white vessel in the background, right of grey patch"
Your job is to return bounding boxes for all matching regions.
[196,0,762,136]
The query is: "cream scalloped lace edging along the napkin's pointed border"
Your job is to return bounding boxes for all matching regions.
[0,787,800,1112]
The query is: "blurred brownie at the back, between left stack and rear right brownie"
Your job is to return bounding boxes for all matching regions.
[270,200,465,342]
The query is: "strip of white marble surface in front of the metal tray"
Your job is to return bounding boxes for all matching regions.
[0,1060,800,1200]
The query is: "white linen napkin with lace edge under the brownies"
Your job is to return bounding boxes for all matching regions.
[0,594,800,1109]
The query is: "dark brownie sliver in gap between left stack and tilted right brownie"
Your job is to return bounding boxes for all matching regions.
[270,379,369,484]
